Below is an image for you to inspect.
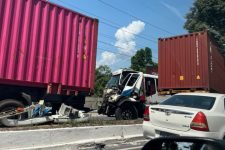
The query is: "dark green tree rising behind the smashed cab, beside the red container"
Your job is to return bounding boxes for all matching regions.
[131,47,157,73]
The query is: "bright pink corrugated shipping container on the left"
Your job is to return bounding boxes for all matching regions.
[0,0,98,90]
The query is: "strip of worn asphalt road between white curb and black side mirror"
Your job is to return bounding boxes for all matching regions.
[78,137,149,150]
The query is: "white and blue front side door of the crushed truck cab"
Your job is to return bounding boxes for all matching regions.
[121,73,143,97]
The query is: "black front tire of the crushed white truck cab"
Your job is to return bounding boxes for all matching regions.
[115,104,138,120]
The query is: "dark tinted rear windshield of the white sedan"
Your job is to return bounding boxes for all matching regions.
[160,95,216,110]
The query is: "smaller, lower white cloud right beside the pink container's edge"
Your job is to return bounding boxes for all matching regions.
[96,51,116,67]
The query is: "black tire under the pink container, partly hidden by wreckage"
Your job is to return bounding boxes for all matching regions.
[0,99,24,126]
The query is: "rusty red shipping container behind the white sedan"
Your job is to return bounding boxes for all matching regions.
[158,32,225,93]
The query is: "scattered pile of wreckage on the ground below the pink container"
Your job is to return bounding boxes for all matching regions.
[0,100,91,127]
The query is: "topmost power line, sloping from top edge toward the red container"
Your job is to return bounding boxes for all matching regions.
[98,0,173,35]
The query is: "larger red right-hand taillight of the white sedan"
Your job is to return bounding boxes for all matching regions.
[191,112,209,131]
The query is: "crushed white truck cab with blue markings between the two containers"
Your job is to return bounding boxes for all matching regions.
[98,69,166,120]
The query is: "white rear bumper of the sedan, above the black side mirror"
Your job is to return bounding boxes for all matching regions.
[143,121,223,139]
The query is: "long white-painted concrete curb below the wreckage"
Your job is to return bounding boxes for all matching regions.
[0,124,143,150]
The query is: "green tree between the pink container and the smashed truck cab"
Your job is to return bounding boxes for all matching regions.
[94,65,111,97]
